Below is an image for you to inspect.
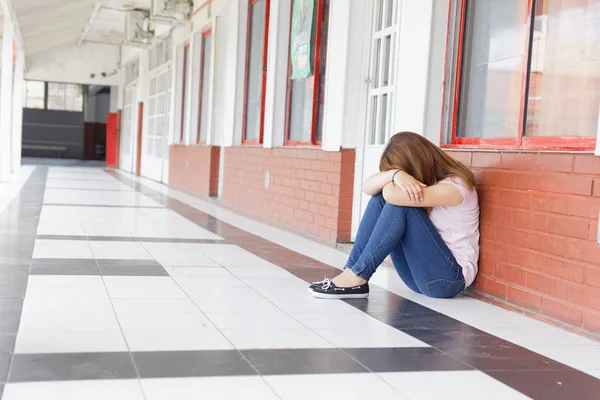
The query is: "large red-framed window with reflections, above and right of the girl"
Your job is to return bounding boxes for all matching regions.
[446,0,600,149]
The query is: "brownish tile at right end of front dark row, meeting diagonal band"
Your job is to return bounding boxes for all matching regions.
[444,346,568,372]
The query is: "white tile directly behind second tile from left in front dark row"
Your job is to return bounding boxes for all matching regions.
[123,328,234,351]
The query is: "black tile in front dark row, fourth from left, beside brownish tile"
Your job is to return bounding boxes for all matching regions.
[344,347,473,372]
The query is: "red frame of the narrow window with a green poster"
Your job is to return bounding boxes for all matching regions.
[285,0,331,146]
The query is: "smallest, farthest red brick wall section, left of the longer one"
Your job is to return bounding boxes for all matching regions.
[169,144,221,198]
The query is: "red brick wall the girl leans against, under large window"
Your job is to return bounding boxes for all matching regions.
[450,152,600,334]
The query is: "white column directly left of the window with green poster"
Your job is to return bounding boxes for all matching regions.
[263,0,290,148]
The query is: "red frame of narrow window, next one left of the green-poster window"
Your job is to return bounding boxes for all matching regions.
[242,0,271,144]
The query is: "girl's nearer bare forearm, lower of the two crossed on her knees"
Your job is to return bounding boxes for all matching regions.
[383,183,463,207]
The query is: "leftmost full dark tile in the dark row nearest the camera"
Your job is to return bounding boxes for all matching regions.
[9,353,137,382]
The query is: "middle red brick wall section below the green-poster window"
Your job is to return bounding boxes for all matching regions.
[222,146,355,243]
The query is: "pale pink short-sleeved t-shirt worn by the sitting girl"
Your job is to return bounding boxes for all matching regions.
[429,177,479,288]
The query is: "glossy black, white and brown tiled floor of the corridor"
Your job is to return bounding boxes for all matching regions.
[0,166,600,400]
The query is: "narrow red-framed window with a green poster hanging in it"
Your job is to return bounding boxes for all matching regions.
[286,0,329,145]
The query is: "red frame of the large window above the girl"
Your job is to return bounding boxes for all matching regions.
[440,0,596,151]
